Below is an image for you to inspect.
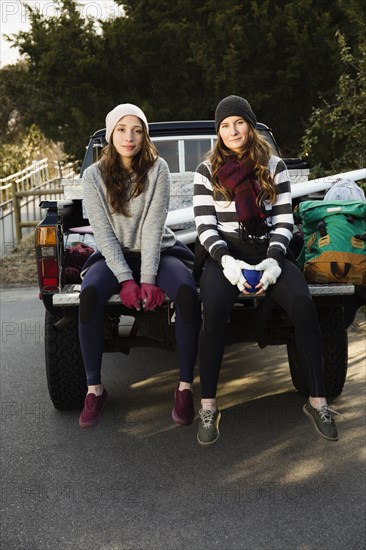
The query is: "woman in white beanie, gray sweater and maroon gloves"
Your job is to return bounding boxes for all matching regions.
[79,103,200,428]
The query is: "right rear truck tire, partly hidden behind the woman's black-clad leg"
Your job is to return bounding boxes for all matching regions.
[287,306,348,398]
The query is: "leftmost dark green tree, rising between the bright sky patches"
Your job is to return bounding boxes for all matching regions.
[7,0,103,162]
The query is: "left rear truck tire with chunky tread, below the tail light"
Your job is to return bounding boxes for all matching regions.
[45,311,87,410]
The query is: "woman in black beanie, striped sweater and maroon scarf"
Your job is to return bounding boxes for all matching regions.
[193,95,338,445]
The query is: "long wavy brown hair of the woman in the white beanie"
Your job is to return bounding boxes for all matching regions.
[99,121,159,217]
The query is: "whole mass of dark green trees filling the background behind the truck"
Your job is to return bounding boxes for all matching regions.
[4,0,364,160]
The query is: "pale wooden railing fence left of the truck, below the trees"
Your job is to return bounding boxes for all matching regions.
[0,158,75,257]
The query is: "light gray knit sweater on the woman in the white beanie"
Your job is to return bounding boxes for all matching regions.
[82,158,176,284]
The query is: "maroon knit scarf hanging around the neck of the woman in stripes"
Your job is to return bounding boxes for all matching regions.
[217,155,268,240]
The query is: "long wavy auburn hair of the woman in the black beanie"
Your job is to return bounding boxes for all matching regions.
[209,125,277,206]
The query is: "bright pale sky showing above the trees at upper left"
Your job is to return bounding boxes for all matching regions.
[0,0,122,67]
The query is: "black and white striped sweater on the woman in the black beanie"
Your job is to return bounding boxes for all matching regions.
[193,156,294,265]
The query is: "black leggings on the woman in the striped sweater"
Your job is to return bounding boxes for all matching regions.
[198,258,325,398]
